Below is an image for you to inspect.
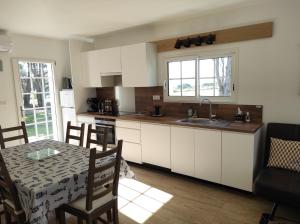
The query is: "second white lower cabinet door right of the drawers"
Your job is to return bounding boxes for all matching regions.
[171,126,195,176]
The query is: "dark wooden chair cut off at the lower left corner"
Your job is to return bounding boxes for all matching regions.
[0,153,26,224]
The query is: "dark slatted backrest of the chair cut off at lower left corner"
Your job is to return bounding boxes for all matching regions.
[0,153,22,211]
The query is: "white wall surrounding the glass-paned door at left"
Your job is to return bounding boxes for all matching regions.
[0,34,70,140]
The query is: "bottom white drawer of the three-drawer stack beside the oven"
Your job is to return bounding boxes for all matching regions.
[122,142,142,164]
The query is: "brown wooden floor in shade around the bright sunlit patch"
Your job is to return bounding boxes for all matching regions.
[8,165,300,224]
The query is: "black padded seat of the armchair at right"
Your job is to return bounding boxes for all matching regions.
[254,168,300,206]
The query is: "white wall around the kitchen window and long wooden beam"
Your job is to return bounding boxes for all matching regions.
[95,0,300,123]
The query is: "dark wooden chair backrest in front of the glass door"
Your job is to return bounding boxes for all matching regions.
[0,121,28,149]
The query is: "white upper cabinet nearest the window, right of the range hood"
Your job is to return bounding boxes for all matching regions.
[121,43,157,87]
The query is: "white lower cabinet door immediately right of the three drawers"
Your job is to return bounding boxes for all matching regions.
[141,123,171,168]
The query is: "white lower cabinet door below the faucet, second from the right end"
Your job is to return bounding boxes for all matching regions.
[195,129,222,183]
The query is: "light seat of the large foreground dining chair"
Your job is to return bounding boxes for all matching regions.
[69,189,117,213]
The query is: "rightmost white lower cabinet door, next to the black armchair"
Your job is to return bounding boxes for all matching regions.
[222,132,254,191]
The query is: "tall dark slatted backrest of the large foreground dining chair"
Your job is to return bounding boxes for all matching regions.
[86,140,123,211]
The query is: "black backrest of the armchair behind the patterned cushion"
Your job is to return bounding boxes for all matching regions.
[264,123,300,167]
